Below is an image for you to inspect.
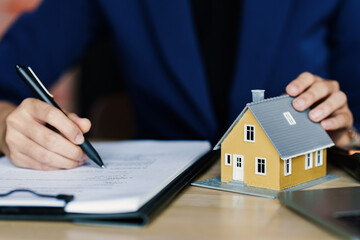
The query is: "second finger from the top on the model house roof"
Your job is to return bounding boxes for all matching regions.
[293,80,339,111]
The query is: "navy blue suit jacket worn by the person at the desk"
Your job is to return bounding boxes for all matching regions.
[0,0,360,142]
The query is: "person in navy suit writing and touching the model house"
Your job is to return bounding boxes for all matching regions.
[0,0,360,170]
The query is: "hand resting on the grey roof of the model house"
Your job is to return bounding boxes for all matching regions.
[286,72,354,147]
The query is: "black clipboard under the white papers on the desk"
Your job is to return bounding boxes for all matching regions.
[0,150,220,226]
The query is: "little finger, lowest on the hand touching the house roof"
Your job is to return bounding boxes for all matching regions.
[320,107,353,131]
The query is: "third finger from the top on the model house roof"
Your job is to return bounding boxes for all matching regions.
[309,91,347,122]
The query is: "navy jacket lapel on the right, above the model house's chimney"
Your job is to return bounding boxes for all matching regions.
[228,0,294,121]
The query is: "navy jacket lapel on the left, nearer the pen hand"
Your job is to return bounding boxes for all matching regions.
[145,0,216,133]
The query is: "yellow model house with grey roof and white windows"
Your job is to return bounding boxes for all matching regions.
[214,90,334,190]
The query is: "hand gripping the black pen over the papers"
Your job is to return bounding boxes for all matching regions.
[0,98,91,170]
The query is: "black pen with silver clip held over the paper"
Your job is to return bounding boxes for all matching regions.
[15,64,105,168]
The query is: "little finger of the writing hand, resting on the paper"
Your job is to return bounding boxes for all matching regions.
[13,132,82,169]
